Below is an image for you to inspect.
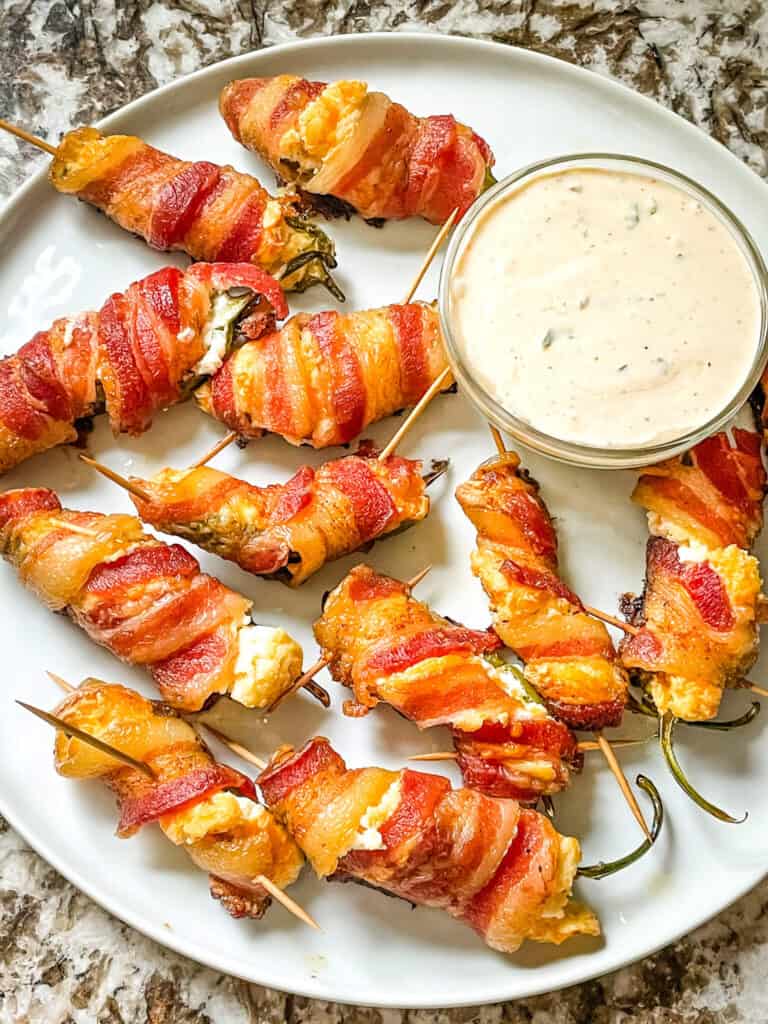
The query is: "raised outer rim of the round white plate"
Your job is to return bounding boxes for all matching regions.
[0,30,768,1010]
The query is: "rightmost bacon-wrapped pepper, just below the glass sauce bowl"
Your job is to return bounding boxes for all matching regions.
[621,428,766,721]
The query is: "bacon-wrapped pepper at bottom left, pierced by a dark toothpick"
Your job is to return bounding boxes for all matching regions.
[55,679,303,918]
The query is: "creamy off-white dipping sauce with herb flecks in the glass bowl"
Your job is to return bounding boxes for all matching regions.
[450,168,761,447]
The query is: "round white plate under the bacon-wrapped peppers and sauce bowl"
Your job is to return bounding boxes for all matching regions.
[0,34,768,1007]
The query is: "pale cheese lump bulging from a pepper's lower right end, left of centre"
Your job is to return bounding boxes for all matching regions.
[230,620,303,708]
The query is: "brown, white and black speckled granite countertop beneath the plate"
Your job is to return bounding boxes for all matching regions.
[0,0,768,1024]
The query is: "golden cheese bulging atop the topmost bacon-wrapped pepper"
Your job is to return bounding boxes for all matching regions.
[280,81,368,169]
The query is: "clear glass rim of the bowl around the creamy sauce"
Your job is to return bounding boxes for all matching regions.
[438,153,768,469]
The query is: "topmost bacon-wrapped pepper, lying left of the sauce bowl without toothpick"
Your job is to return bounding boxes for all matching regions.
[219,75,494,224]
